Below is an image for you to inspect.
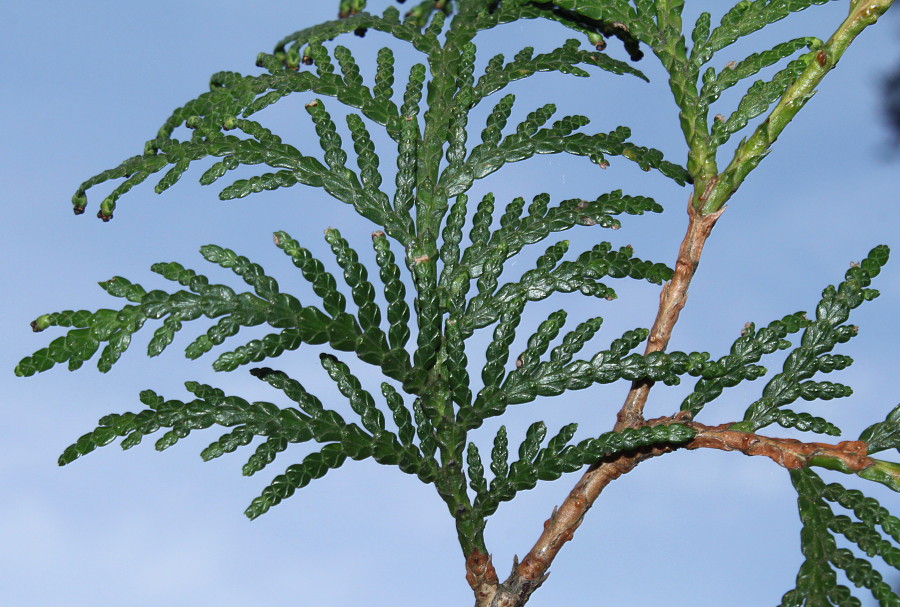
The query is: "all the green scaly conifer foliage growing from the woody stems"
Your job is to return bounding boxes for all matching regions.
[16,0,900,606]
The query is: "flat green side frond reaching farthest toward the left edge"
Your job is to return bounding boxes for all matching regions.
[16,239,409,380]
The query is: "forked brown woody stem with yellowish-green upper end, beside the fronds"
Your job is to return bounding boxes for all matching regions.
[467,0,893,607]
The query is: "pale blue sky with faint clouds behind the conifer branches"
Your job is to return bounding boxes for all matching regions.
[0,0,900,607]
